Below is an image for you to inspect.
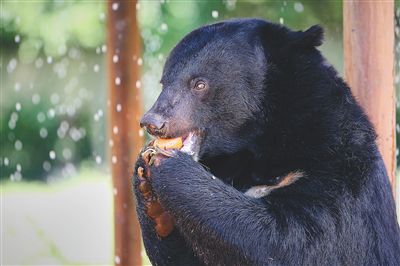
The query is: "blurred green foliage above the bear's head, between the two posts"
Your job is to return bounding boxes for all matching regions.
[139,0,342,70]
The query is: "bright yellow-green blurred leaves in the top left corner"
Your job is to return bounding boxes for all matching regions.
[0,0,105,59]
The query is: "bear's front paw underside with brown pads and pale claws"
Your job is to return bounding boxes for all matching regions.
[136,147,174,237]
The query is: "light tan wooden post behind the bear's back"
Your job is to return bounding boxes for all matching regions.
[343,0,396,193]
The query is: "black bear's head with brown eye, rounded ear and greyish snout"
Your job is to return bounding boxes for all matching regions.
[141,19,322,161]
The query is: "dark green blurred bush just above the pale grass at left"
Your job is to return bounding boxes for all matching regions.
[0,102,91,181]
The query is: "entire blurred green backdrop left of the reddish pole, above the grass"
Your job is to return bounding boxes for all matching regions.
[0,1,107,181]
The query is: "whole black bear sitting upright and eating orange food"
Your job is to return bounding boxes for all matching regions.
[134,19,400,265]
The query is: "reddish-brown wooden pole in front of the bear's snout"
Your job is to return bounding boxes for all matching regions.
[107,0,143,265]
